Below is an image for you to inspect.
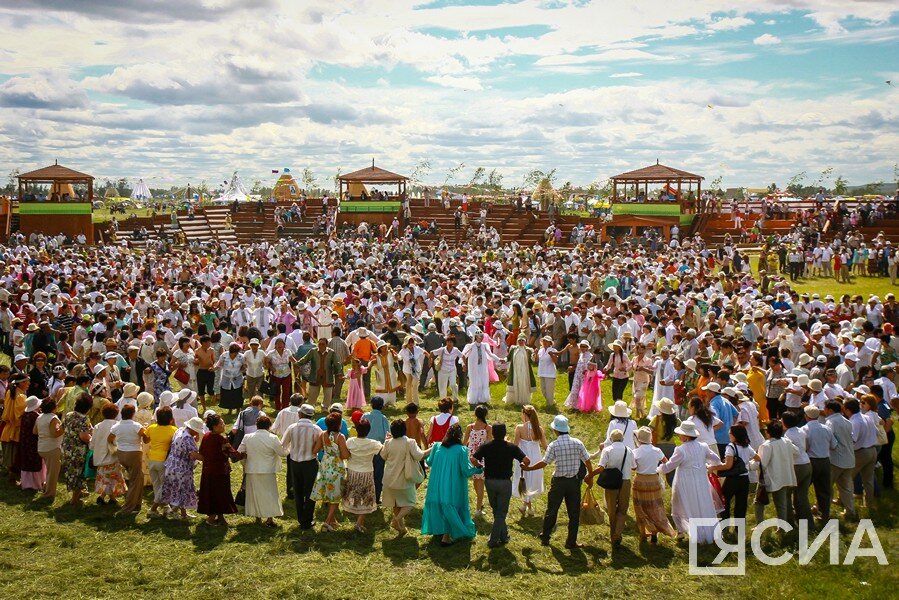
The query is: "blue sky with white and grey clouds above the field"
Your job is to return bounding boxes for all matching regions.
[0,0,899,186]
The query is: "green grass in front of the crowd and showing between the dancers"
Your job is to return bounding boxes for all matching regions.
[0,366,899,599]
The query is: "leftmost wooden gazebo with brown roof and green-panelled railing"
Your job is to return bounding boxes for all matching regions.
[17,162,94,244]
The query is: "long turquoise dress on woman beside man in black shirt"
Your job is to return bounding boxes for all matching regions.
[421,442,483,539]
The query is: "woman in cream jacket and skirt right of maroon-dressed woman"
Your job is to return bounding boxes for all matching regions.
[237,414,290,527]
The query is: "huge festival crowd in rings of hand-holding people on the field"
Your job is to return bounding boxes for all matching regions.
[0,223,899,547]
